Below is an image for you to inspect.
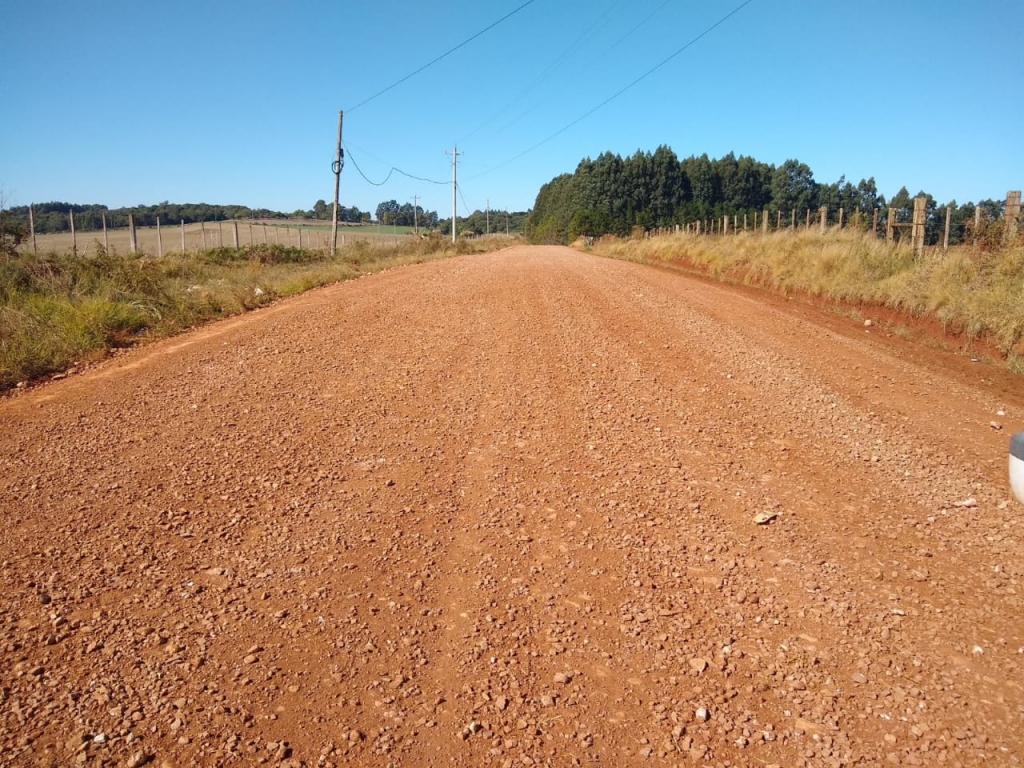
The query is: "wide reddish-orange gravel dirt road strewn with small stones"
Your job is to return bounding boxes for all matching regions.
[0,248,1024,768]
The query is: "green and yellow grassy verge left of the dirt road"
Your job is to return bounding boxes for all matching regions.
[0,238,509,391]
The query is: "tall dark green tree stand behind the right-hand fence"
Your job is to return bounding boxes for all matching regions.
[525,144,1005,244]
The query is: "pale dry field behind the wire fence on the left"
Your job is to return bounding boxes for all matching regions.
[22,219,413,256]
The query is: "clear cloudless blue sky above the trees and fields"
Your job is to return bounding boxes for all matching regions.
[0,0,1024,218]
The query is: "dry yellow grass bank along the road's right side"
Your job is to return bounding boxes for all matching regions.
[593,230,1024,373]
